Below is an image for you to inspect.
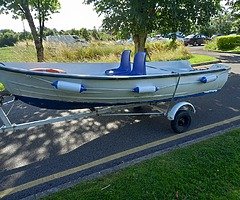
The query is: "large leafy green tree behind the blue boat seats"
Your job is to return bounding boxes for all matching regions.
[85,0,220,52]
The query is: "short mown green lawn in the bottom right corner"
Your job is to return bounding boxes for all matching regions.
[45,129,240,200]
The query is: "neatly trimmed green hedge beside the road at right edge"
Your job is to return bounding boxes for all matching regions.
[216,35,240,51]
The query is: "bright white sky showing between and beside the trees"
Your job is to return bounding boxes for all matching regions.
[0,0,103,32]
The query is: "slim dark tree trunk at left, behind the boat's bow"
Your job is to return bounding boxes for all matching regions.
[21,4,44,62]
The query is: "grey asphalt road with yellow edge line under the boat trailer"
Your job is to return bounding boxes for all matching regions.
[0,47,240,199]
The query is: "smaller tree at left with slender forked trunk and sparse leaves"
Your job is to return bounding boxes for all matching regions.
[0,0,60,62]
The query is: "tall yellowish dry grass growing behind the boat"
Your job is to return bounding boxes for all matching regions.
[0,42,218,63]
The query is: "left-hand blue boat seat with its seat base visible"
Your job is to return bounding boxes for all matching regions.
[105,50,131,76]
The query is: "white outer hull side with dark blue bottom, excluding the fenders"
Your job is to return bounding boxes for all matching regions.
[0,62,229,109]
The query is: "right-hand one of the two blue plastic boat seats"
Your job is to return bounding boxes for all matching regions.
[130,52,146,76]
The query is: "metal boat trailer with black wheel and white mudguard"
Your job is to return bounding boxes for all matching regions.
[0,93,196,133]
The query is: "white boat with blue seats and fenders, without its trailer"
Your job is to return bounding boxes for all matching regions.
[0,50,230,109]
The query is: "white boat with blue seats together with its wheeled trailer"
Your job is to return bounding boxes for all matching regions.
[0,50,230,133]
